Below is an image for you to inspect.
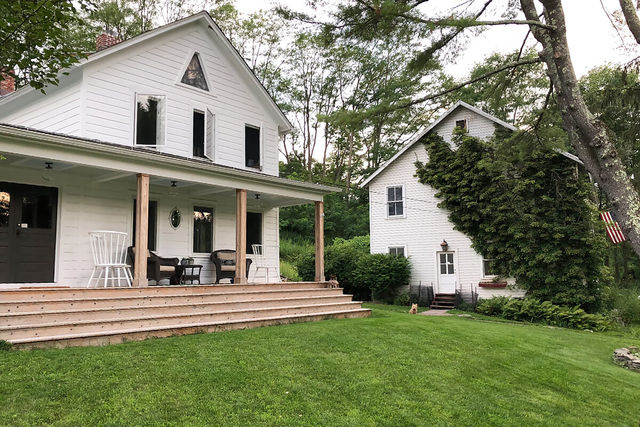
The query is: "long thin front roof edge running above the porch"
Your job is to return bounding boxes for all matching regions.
[0,123,341,195]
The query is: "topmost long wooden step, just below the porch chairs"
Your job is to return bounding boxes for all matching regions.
[0,288,343,314]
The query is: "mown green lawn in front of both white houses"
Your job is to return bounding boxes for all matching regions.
[0,306,640,426]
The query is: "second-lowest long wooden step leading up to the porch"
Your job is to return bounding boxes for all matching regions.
[0,302,360,342]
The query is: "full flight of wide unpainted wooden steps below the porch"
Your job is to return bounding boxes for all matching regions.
[0,282,371,348]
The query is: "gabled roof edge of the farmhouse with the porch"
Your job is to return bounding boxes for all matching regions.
[0,10,293,131]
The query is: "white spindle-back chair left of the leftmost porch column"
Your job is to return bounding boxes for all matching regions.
[87,230,133,288]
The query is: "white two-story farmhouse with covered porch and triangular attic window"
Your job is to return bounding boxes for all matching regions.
[0,12,336,288]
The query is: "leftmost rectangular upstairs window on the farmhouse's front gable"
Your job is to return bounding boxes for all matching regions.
[135,94,166,146]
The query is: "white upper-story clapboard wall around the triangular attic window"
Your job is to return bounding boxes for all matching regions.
[79,24,278,175]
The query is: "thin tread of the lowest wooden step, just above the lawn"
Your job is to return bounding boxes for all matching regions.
[8,308,371,344]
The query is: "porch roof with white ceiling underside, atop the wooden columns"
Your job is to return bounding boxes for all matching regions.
[0,124,339,208]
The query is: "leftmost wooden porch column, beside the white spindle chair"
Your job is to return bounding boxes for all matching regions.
[133,173,149,286]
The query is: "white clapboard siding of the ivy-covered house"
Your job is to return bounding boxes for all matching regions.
[369,107,521,297]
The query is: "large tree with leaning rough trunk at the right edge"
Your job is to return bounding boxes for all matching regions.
[301,0,640,260]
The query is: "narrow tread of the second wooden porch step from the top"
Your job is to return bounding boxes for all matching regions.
[0,294,353,319]
